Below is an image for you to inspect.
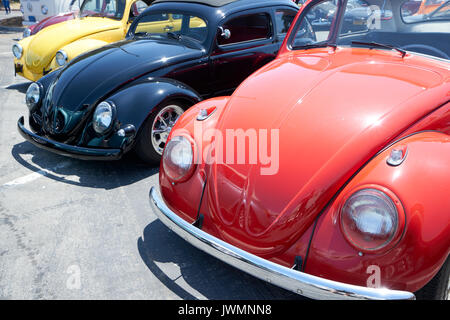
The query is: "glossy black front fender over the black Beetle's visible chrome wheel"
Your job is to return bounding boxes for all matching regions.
[106,77,202,135]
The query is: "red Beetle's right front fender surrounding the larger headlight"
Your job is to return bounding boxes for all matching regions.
[305,131,450,292]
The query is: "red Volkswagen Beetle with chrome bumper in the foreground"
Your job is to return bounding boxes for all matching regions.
[150,0,450,299]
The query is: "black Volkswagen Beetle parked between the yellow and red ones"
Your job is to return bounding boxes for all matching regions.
[18,0,298,164]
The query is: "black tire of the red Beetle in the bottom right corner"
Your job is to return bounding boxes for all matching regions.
[416,257,450,300]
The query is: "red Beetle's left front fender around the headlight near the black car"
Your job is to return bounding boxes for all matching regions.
[159,97,229,222]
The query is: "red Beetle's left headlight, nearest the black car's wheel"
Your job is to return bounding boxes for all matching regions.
[162,136,195,182]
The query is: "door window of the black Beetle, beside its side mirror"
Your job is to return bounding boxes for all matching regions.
[217,13,272,45]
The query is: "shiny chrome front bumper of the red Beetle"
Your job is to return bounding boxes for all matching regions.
[149,187,415,300]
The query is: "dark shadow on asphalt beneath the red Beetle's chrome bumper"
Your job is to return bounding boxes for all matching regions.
[137,220,306,300]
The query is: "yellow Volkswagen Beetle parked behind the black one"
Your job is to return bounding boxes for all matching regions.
[12,0,155,81]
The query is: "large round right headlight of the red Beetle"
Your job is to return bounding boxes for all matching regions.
[340,188,404,252]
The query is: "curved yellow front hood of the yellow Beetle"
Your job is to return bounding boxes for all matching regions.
[24,17,122,73]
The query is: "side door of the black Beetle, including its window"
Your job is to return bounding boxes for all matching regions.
[211,7,280,95]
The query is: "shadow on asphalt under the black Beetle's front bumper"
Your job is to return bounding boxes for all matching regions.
[11,141,159,190]
